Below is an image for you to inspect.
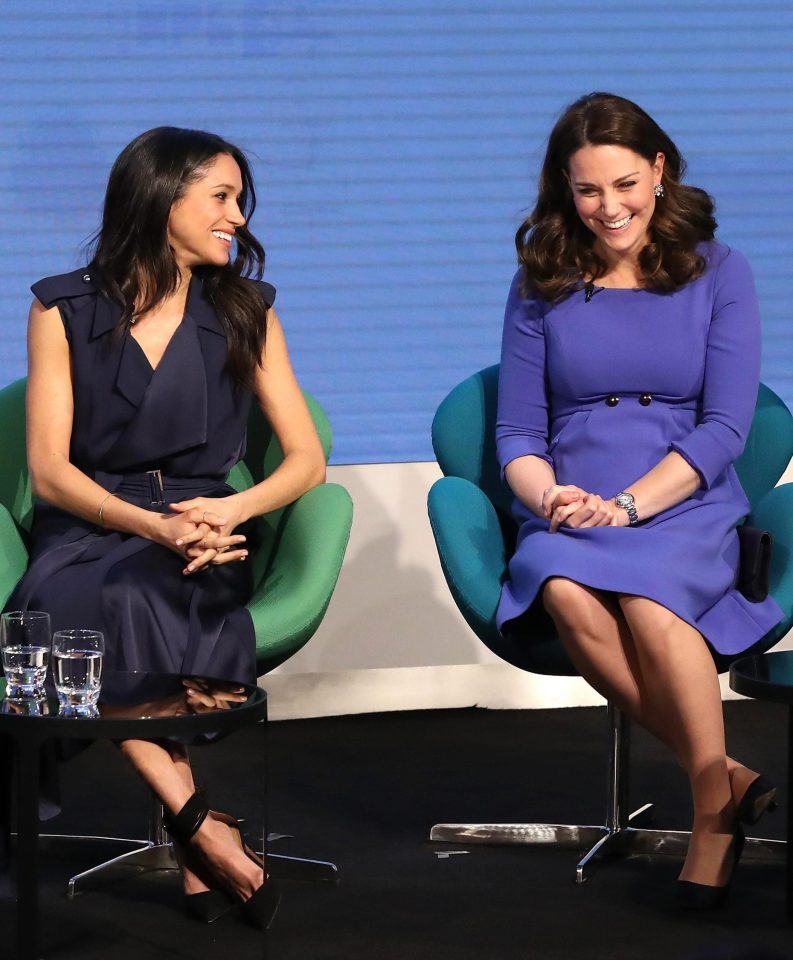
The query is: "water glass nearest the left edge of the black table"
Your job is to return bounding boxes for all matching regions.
[0,610,52,699]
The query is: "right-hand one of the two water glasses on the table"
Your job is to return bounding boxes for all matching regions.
[52,630,105,717]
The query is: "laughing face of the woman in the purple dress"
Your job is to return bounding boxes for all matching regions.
[567,145,664,265]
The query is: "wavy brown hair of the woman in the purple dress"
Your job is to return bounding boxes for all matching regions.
[515,93,716,301]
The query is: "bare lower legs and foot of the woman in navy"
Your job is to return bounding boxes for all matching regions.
[120,740,262,900]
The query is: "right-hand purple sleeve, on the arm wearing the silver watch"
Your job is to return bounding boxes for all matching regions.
[670,250,760,489]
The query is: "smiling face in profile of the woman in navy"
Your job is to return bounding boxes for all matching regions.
[168,153,245,271]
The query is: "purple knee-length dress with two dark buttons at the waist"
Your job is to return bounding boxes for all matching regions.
[496,241,782,654]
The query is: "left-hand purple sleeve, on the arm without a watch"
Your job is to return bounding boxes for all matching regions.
[496,270,553,476]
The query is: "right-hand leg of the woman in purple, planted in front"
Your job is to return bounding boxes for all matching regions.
[619,596,735,886]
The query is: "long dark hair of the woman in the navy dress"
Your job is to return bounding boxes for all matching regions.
[90,127,269,385]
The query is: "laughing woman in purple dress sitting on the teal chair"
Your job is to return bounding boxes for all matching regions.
[497,93,782,908]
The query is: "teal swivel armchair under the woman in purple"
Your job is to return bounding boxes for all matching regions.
[428,366,793,883]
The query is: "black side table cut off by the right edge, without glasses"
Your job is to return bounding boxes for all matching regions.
[730,650,793,921]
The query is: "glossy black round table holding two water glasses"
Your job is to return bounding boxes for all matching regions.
[0,672,267,960]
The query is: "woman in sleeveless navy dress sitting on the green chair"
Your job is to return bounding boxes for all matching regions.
[9,127,325,925]
